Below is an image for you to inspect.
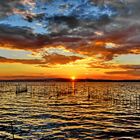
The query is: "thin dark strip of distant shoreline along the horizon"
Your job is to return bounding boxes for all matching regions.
[0,78,140,82]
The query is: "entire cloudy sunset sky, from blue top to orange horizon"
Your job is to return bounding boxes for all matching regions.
[0,0,140,80]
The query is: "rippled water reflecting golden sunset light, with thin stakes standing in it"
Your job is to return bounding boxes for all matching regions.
[0,82,140,140]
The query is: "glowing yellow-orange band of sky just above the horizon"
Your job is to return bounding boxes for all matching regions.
[0,46,139,79]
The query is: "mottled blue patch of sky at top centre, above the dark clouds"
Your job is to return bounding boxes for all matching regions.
[35,0,117,20]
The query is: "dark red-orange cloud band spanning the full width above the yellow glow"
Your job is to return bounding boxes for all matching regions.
[0,23,140,61]
